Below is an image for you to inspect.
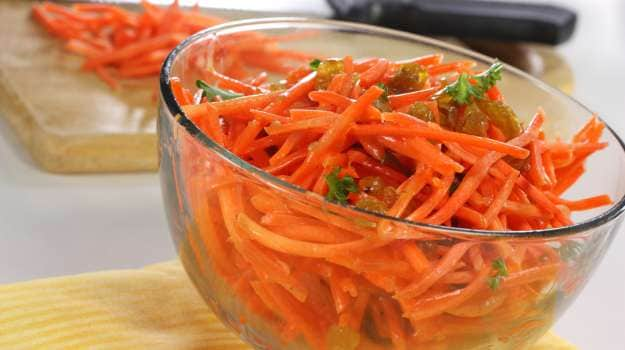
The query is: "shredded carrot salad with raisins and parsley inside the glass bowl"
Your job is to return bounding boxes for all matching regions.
[171,47,612,349]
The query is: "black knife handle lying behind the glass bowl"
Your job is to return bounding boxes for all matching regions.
[328,0,577,45]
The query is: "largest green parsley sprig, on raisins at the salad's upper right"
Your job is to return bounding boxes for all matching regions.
[442,62,503,104]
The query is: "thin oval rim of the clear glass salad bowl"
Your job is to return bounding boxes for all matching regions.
[159,17,625,239]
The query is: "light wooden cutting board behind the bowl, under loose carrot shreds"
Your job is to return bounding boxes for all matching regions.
[0,0,572,173]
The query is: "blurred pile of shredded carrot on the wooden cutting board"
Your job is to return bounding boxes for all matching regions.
[32,0,309,93]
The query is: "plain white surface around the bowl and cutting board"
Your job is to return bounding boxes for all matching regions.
[0,0,625,350]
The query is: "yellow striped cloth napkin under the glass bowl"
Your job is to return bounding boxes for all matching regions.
[0,261,575,350]
